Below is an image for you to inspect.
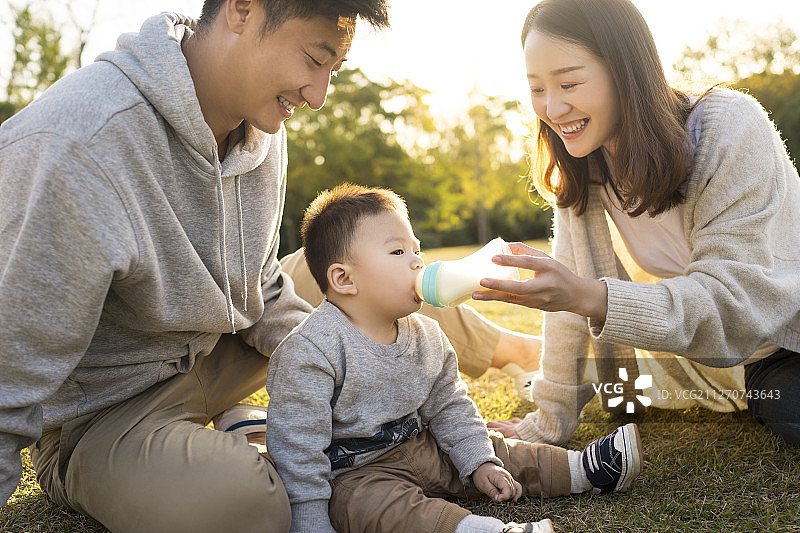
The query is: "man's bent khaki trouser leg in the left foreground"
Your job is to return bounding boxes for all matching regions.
[31,335,291,533]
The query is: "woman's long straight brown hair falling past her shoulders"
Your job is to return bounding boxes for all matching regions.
[522,0,692,216]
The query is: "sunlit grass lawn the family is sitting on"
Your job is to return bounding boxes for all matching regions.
[0,242,800,533]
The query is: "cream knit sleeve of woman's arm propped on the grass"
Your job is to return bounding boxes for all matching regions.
[517,209,594,444]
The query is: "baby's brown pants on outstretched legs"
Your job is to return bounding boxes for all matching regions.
[330,430,570,533]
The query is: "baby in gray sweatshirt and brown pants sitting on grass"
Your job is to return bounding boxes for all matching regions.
[267,184,641,533]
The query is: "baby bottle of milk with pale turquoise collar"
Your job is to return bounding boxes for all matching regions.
[414,237,519,307]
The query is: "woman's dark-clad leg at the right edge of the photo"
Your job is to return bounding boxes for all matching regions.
[744,348,800,445]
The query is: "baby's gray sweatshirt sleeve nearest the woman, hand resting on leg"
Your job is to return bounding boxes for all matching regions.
[419,328,503,485]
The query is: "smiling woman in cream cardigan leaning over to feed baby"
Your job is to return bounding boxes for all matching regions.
[474,0,800,444]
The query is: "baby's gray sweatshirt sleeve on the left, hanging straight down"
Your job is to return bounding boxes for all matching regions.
[267,331,335,531]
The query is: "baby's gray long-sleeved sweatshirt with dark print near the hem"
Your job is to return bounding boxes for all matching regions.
[267,300,502,531]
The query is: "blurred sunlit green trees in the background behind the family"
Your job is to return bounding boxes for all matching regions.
[0,0,800,253]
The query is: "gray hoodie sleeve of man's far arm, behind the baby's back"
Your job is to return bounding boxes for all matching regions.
[240,128,313,356]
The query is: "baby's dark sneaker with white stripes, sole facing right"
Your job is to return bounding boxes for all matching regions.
[581,424,642,493]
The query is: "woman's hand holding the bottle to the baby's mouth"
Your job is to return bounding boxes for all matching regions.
[472,242,608,322]
